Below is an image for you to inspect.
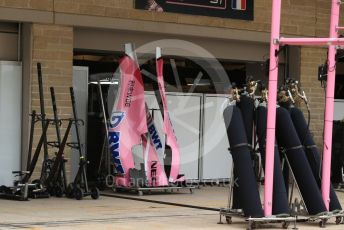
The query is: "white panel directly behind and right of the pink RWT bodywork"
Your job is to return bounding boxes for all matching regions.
[146,92,202,180]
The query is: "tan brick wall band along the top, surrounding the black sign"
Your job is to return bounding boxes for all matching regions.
[0,0,344,36]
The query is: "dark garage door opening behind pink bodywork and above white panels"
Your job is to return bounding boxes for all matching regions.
[74,50,276,185]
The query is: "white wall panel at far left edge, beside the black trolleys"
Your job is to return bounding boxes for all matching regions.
[0,61,22,186]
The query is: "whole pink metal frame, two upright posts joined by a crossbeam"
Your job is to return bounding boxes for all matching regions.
[264,0,344,216]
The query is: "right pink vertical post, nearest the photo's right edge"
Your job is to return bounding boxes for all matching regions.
[321,0,340,210]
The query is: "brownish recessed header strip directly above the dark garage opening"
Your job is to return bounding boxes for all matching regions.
[74,28,270,61]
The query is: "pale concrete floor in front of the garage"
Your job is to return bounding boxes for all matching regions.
[0,187,344,230]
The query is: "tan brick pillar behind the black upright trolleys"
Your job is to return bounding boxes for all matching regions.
[31,24,73,178]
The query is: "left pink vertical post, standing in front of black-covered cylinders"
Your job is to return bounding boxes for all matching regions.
[264,0,281,216]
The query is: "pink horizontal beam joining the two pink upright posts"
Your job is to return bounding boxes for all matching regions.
[278,37,344,46]
